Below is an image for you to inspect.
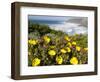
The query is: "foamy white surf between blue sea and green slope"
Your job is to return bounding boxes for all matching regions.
[49,22,88,35]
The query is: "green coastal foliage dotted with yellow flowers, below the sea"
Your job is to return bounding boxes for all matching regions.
[28,23,88,66]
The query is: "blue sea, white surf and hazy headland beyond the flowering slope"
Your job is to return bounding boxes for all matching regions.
[28,15,88,35]
